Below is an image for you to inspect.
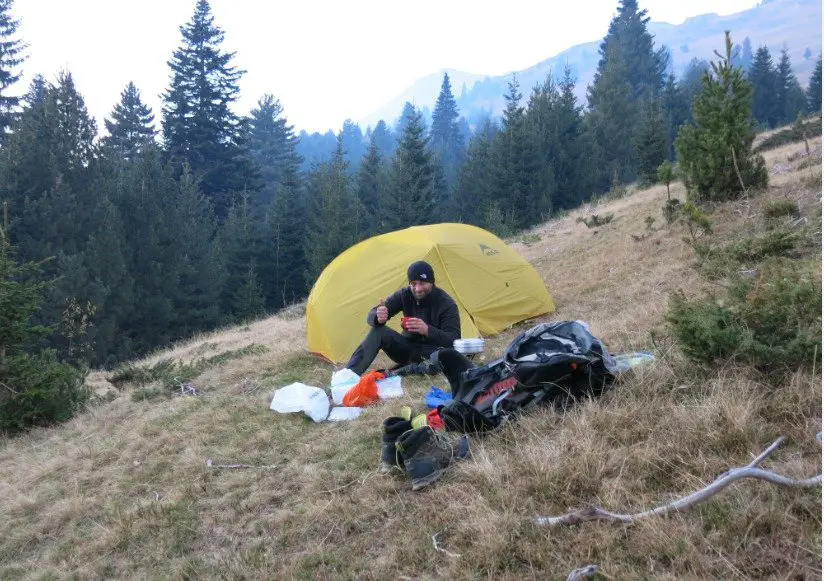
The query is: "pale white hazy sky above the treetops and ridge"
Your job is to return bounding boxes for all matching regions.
[12,0,757,131]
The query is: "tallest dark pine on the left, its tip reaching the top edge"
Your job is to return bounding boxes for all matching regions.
[162,0,253,216]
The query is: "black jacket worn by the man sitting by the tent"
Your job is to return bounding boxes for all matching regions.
[366,287,461,353]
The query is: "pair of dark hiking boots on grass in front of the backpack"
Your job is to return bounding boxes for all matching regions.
[381,416,469,490]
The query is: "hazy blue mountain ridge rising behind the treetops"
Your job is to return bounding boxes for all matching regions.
[359,0,822,127]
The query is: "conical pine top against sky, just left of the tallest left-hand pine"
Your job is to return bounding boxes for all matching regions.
[103,82,157,161]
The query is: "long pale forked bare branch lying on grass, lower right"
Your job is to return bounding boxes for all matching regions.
[535,436,822,526]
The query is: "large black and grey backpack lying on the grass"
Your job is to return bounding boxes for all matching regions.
[438,321,617,433]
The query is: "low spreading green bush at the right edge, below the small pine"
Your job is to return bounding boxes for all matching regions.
[666,262,821,371]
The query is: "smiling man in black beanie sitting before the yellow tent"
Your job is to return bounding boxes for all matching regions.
[346,261,461,375]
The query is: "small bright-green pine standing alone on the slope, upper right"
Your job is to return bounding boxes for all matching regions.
[676,31,767,200]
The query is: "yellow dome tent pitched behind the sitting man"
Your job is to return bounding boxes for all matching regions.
[306,224,555,363]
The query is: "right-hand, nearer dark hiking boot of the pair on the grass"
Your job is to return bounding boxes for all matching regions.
[396,426,469,490]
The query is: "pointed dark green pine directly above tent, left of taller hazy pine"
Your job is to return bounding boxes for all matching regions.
[384,107,439,230]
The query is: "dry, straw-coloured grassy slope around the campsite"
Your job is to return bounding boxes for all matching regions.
[0,140,821,579]
